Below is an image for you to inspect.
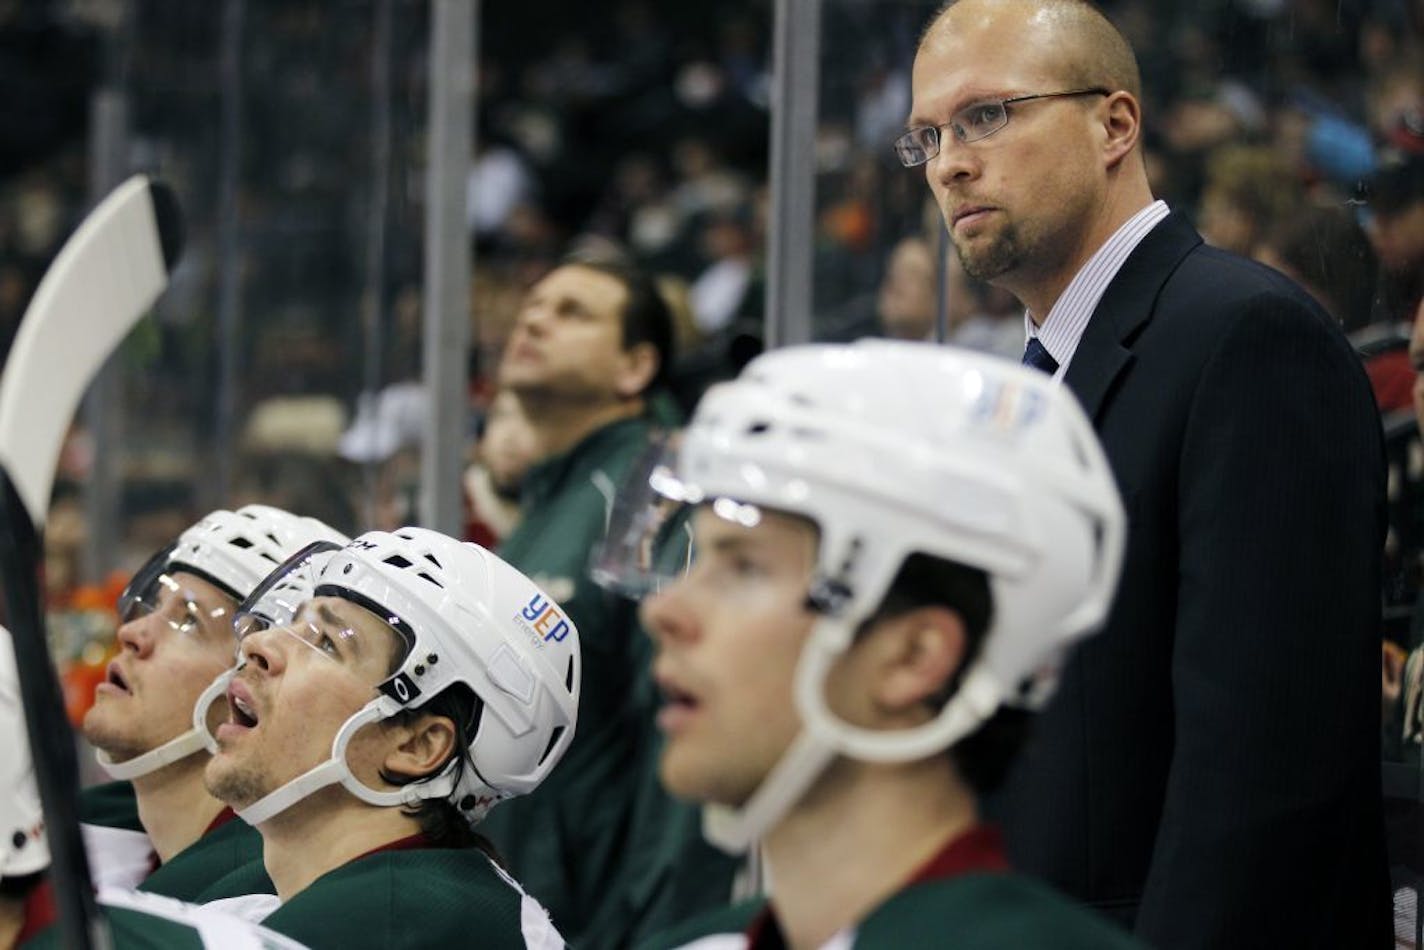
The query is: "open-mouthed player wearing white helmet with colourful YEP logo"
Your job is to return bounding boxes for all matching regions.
[11,528,580,947]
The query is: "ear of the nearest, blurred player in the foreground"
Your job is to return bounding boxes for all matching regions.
[871,607,967,716]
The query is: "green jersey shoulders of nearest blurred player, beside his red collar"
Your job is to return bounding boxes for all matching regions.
[641,872,1143,950]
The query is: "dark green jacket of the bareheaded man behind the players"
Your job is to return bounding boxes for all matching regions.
[480,419,732,950]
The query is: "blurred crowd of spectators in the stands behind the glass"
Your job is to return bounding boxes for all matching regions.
[0,0,1424,706]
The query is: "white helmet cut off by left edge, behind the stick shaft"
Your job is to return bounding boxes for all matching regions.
[0,627,50,879]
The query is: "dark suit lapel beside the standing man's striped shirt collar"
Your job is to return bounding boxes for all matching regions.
[1064,212,1202,422]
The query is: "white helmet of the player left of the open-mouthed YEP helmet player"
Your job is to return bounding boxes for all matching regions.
[97,504,347,779]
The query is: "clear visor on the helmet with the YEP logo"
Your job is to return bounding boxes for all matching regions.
[234,541,414,687]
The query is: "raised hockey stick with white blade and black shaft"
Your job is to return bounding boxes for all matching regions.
[0,175,182,949]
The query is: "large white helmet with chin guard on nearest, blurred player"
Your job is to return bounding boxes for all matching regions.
[601,340,1125,850]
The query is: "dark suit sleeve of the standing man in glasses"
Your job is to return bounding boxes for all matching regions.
[1138,293,1387,947]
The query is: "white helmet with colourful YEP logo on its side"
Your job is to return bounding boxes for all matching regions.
[226,527,581,825]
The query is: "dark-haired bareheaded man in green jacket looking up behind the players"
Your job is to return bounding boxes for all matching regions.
[486,262,735,950]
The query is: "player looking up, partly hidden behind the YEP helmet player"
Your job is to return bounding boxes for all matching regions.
[11,504,346,934]
